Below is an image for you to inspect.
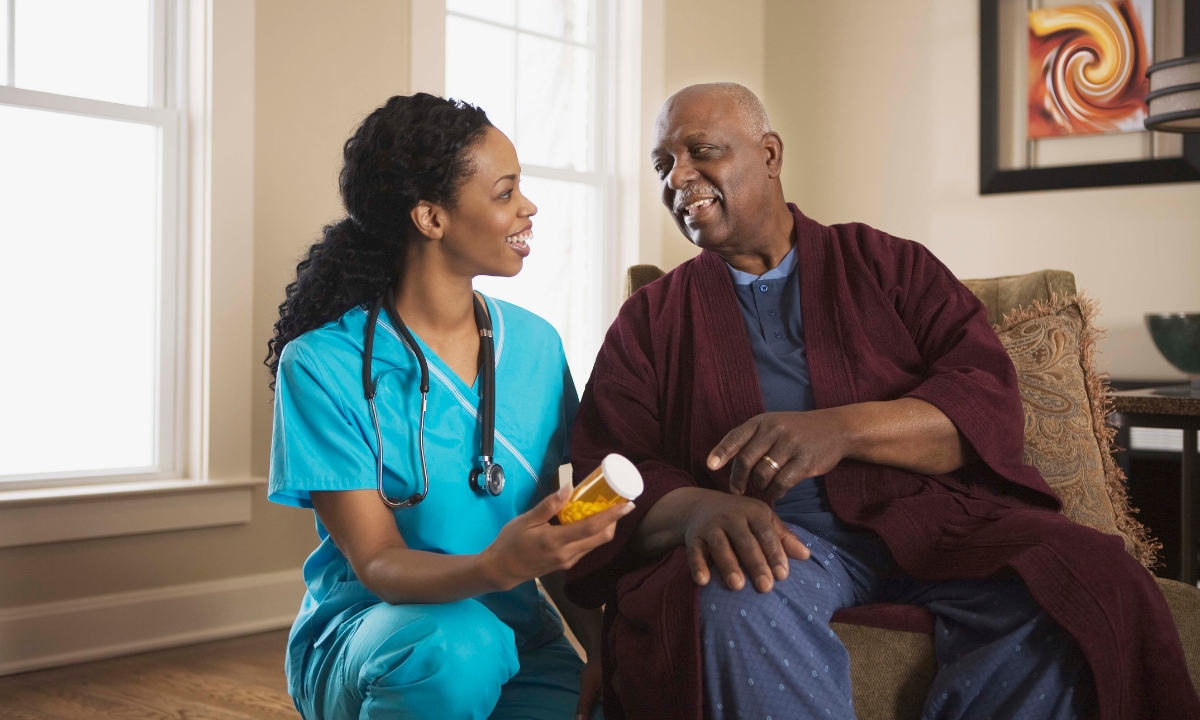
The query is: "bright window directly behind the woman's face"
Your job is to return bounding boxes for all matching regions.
[444,0,617,388]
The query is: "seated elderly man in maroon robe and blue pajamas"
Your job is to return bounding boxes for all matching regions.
[568,83,1200,720]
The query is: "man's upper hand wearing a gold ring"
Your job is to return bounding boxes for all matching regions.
[708,410,848,500]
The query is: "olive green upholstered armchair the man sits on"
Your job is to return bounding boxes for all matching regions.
[625,265,1200,720]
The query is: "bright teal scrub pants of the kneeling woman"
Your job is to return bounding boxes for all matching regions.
[295,600,599,720]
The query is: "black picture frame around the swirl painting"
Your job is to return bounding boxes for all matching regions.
[979,0,1200,194]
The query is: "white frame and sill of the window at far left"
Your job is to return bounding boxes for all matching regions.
[0,0,266,547]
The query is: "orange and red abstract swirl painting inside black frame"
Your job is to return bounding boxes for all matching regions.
[1028,0,1154,138]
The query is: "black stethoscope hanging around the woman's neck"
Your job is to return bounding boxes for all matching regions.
[362,288,504,508]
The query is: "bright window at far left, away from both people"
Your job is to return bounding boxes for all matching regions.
[0,0,182,487]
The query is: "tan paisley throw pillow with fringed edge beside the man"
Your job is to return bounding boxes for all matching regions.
[996,295,1162,568]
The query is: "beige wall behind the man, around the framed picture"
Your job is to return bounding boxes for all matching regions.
[764,0,1200,378]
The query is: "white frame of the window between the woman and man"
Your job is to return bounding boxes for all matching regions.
[420,0,644,340]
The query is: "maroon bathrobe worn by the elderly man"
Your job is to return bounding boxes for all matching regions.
[566,205,1200,720]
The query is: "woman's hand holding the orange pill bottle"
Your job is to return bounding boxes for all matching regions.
[480,486,634,590]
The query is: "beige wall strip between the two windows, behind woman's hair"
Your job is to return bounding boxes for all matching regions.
[250,0,408,477]
